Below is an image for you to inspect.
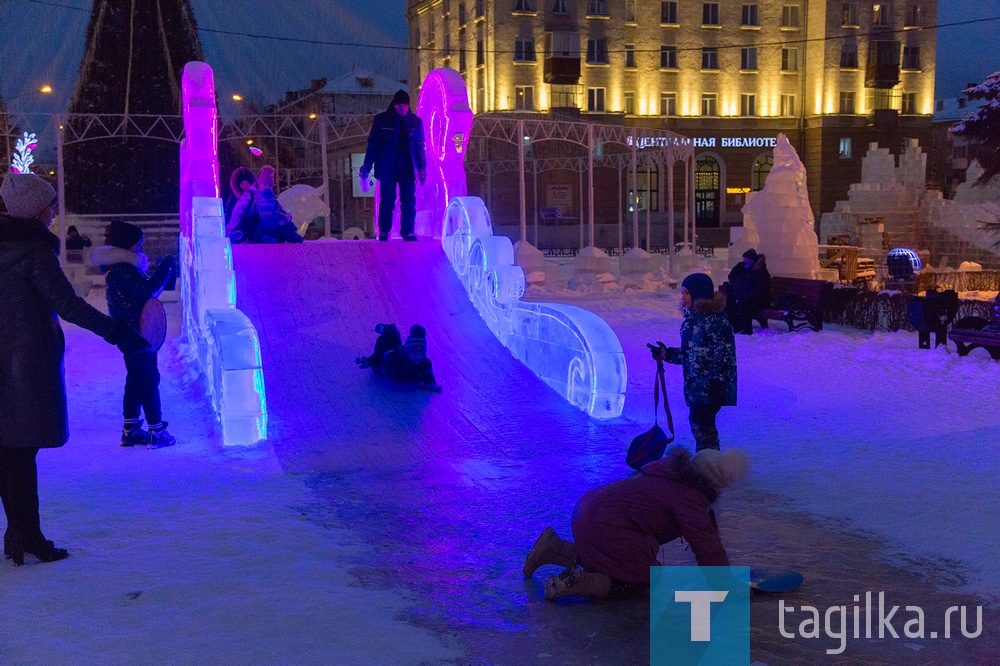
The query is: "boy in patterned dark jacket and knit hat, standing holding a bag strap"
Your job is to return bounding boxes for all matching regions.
[653,273,736,451]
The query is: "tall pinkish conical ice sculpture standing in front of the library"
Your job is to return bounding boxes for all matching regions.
[730,134,819,278]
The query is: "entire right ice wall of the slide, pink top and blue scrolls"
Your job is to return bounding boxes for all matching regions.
[417,69,627,418]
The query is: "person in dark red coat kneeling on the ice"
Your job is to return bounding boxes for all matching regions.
[524,446,749,599]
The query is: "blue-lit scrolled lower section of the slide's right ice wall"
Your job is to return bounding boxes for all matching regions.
[441,197,627,418]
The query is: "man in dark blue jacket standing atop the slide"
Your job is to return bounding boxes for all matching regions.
[359,90,427,241]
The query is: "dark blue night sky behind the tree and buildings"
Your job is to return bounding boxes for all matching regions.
[0,0,1000,113]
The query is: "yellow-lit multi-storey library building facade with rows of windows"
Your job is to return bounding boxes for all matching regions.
[408,0,937,236]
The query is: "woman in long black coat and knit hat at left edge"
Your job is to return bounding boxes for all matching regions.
[0,172,148,564]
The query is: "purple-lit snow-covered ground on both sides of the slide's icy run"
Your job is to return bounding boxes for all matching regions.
[0,268,1000,664]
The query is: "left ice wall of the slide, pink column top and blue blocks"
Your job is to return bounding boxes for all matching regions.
[179,62,267,446]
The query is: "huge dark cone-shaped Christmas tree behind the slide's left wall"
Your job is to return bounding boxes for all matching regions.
[65,0,204,213]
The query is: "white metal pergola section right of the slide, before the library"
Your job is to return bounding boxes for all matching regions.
[465,114,695,270]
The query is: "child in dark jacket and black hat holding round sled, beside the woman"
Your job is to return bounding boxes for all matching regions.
[91,222,175,448]
